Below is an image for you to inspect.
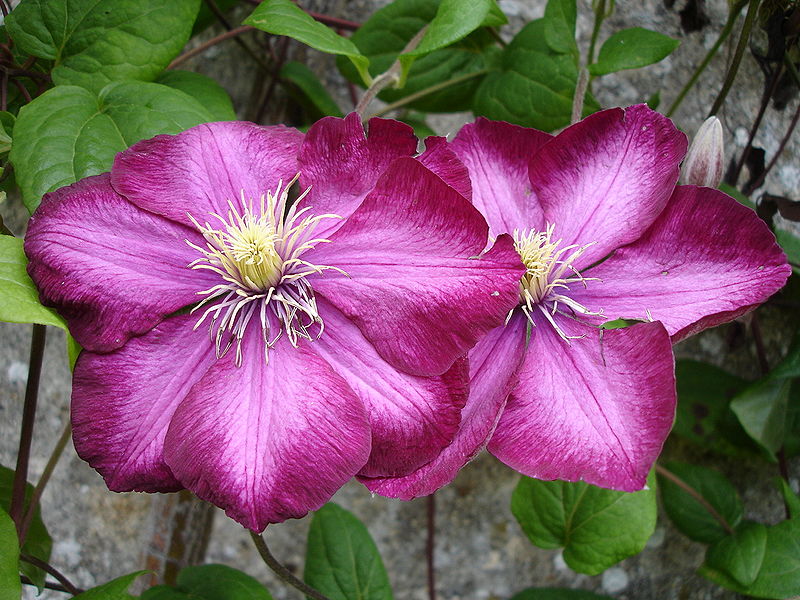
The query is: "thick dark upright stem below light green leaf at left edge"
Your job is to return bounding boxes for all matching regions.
[8,324,47,535]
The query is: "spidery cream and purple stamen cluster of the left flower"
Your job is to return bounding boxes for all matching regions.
[186,176,344,366]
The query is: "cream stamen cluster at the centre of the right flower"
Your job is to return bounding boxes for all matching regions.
[509,225,603,341]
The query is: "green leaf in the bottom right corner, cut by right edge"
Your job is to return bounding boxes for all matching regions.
[699,519,800,598]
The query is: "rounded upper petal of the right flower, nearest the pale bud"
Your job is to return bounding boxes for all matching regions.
[530,104,687,269]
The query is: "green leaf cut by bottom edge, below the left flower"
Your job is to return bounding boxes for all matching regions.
[141,565,272,600]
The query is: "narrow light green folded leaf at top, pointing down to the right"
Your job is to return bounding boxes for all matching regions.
[244,0,372,85]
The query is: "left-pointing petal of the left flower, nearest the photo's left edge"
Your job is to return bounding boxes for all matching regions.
[25,174,217,352]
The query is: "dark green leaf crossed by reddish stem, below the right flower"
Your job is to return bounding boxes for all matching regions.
[659,462,743,544]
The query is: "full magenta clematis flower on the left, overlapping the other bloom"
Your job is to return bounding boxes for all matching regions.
[25,115,524,531]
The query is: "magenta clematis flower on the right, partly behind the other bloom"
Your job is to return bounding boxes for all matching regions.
[365,106,790,498]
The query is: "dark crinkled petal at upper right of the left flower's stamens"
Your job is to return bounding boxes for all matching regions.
[299,113,417,236]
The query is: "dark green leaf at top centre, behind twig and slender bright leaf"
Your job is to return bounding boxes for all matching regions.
[336,0,500,112]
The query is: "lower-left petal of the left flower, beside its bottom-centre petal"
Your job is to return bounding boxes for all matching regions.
[71,315,216,492]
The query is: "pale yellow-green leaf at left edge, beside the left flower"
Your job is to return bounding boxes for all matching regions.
[0,235,67,330]
